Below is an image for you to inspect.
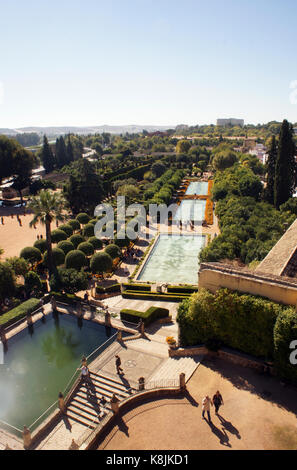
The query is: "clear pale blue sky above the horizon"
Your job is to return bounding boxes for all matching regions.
[0,0,297,127]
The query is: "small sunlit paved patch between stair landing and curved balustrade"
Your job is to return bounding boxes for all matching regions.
[149,355,203,382]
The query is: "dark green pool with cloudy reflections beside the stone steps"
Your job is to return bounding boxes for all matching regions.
[0,314,116,429]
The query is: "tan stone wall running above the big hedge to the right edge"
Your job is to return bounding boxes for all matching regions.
[198,263,297,306]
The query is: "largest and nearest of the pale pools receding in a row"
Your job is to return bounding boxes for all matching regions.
[137,234,205,284]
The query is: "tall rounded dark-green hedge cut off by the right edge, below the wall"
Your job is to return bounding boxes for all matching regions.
[274,308,297,383]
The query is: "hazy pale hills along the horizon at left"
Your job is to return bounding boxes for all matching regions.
[0,125,170,136]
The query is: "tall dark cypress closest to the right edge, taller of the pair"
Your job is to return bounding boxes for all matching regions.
[274,120,296,209]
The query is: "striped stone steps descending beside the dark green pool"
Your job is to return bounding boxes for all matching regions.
[67,372,133,429]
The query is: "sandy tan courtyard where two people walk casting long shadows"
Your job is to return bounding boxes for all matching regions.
[99,360,297,451]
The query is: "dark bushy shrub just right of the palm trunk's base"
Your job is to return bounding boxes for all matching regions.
[50,268,88,294]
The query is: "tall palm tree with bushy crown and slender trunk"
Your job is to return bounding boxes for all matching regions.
[28,189,67,274]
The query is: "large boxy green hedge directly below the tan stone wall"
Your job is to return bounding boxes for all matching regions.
[177,289,284,358]
